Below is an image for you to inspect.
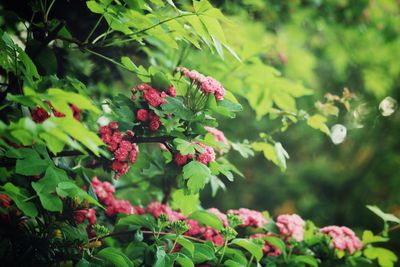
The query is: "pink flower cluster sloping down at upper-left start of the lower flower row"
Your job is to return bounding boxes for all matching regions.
[92,177,143,216]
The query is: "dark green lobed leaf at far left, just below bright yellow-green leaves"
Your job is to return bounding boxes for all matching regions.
[15,148,52,176]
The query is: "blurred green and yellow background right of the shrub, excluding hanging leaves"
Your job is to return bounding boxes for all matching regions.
[199,0,400,249]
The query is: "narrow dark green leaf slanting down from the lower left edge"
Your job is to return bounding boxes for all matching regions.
[0,183,38,217]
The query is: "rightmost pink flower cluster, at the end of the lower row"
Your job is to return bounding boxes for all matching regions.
[320,225,362,254]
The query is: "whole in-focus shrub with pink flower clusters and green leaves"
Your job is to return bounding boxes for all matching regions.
[0,0,400,266]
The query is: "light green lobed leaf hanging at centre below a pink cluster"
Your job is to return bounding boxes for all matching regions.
[183,160,211,194]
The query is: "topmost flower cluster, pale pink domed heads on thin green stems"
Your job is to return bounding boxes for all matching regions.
[176,67,225,101]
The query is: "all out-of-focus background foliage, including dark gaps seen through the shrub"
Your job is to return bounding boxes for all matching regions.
[1,0,400,255]
